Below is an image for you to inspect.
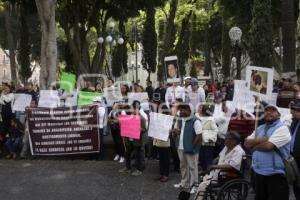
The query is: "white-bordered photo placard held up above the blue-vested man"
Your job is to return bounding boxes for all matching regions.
[246,66,273,97]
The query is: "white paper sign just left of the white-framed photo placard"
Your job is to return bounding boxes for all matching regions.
[231,80,255,113]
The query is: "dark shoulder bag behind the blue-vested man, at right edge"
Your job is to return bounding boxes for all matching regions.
[275,149,300,187]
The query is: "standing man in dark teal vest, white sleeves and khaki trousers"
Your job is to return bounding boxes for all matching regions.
[172,104,202,193]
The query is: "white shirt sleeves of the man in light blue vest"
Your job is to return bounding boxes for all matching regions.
[247,126,291,148]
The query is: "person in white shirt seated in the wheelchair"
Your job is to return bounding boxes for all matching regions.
[195,131,245,200]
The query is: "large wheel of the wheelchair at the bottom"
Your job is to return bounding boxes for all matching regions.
[217,179,250,200]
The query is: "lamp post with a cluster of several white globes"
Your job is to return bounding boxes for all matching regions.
[98,22,124,77]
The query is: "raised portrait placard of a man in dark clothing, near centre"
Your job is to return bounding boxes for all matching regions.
[165,56,180,83]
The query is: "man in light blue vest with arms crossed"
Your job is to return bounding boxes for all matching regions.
[245,105,291,200]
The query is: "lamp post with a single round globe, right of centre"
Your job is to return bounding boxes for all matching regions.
[229,26,243,79]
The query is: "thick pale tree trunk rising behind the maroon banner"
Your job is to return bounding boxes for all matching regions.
[35,0,57,89]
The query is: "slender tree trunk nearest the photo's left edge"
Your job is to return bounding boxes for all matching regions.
[4,1,18,84]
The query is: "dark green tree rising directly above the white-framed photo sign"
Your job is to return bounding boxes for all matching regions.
[249,0,273,67]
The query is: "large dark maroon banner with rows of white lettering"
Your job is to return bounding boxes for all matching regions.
[27,105,100,155]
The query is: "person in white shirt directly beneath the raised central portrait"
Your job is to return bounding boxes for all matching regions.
[165,83,185,108]
